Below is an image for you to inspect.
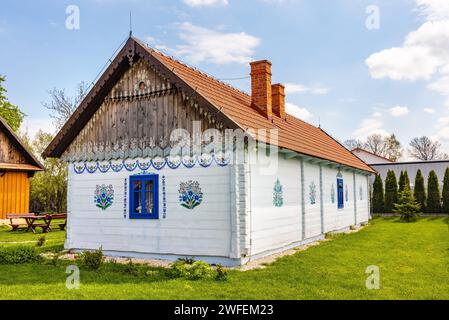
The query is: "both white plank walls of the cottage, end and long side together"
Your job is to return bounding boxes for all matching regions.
[66,152,369,259]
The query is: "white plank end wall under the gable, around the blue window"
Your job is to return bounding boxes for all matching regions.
[66,161,231,257]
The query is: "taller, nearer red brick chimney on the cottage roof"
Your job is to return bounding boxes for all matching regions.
[250,60,273,118]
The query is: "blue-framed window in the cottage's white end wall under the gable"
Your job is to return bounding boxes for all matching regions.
[129,174,159,219]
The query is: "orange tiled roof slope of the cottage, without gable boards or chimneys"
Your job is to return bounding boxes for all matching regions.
[141,40,375,172]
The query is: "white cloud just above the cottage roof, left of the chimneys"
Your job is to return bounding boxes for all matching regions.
[167,22,261,64]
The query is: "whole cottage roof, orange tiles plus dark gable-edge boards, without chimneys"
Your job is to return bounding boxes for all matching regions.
[44,38,375,172]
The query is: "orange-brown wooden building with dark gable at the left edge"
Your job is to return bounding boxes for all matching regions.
[0,117,43,219]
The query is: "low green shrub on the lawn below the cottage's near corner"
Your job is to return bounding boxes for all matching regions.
[171,259,215,280]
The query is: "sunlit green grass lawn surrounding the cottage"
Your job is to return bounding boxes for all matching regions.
[0,218,449,299]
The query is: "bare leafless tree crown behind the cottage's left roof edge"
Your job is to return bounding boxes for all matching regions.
[42,82,87,130]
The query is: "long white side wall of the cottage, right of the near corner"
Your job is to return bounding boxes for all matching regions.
[249,152,369,255]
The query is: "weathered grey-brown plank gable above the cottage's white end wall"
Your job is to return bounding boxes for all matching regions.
[64,60,221,157]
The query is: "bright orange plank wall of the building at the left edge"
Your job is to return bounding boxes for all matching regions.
[0,172,30,219]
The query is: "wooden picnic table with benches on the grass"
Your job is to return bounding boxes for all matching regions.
[7,213,67,233]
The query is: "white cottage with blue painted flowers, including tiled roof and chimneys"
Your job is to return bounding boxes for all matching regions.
[44,37,374,266]
